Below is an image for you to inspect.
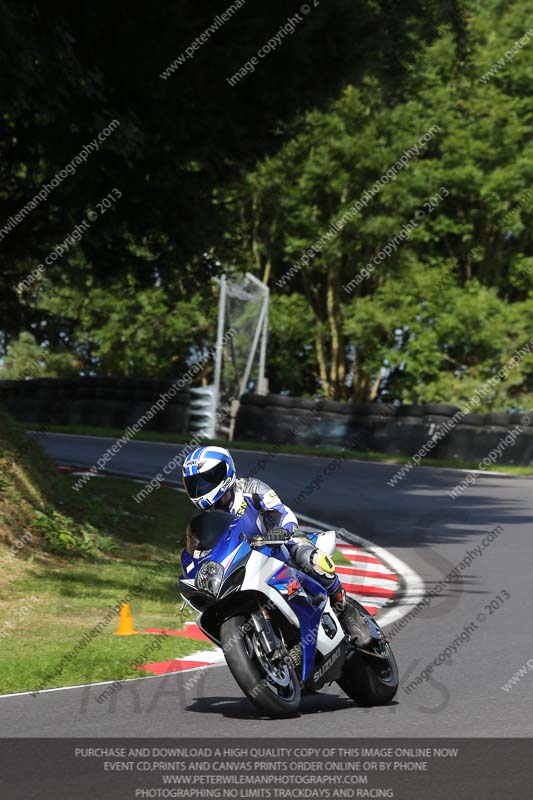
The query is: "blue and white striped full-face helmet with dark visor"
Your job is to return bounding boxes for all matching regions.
[183,445,236,511]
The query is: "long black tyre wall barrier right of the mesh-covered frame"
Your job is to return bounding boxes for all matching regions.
[235,394,533,466]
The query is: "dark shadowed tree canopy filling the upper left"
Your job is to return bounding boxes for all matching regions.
[0,0,458,356]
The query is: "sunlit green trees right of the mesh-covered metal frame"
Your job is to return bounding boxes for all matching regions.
[223,0,533,410]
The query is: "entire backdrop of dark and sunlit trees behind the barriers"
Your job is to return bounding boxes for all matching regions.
[4,0,533,410]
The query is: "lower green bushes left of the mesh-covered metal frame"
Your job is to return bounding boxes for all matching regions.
[39,273,216,377]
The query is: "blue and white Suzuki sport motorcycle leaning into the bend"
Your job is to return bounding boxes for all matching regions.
[179,511,398,717]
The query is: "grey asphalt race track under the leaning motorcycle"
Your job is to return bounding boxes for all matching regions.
[0,434,533,738]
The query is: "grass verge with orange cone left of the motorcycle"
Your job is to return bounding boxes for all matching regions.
[0,475,202,694]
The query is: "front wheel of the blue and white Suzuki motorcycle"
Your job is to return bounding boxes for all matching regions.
[220,615,300,717]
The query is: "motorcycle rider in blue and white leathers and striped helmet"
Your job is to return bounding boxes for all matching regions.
[182,445,371,647]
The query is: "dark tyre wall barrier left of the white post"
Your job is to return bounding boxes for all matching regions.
[0,378,190,435]
